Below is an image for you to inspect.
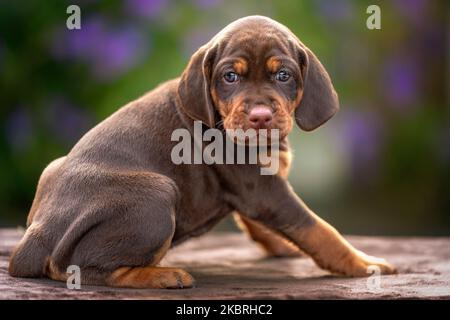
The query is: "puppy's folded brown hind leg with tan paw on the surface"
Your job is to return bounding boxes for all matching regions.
[48,174,194,289]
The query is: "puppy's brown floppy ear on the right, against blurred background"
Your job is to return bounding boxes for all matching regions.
[295,45,339,131]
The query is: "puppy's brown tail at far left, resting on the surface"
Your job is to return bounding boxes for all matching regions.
[8,225,50,278]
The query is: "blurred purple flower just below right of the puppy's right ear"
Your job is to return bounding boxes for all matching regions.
[342,111,384,181]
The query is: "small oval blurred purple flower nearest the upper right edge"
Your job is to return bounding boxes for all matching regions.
[381,55,421,110]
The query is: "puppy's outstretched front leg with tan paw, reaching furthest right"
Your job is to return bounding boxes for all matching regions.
[253,181,396,277]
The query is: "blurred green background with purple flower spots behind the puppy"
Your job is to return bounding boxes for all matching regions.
[0,0,450,235]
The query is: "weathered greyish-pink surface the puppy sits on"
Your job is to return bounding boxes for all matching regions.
[0,229,450,299]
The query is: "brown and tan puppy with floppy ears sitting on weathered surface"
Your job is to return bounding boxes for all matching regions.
[9,16,395,288]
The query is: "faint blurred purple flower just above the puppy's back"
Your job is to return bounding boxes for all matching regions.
[45,96,93,145]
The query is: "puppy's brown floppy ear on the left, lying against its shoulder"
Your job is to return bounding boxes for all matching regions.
[178,45,216,128]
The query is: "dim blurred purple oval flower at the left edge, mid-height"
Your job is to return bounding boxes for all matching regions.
[5,106,33,151]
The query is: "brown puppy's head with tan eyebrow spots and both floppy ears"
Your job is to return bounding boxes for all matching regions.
[178,16,339,142]
